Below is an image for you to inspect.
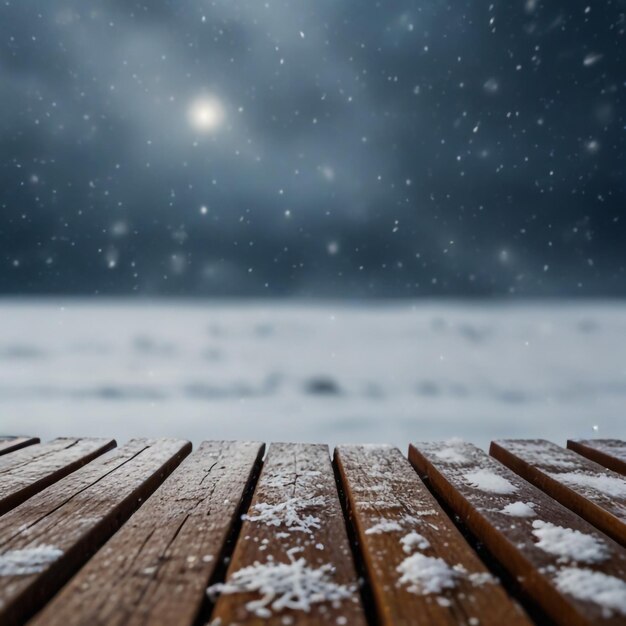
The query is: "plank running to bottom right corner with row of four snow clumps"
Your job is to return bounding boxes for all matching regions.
[409,443,626,626]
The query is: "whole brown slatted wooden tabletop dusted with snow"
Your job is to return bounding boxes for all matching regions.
[0,437,626,626]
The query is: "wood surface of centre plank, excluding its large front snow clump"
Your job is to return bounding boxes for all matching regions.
[211,444,366,626]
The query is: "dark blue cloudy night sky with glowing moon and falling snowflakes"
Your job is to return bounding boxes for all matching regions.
[0,0,626,298]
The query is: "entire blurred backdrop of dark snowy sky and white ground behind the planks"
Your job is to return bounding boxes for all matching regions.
[0,0,626,448]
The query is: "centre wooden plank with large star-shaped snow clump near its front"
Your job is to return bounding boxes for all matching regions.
[210,444,366,626]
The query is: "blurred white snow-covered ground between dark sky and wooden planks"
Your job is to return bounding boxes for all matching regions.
[0,299,626,450]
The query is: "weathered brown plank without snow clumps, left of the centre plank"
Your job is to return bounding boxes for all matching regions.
[30,441,264,626]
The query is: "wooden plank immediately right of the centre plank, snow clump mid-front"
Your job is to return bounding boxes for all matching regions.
[335,446,531,626]
